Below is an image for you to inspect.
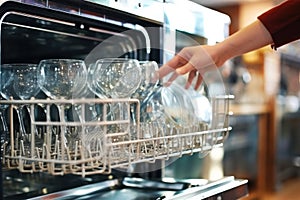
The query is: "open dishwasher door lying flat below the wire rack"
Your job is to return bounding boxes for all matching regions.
[22,177,248,200]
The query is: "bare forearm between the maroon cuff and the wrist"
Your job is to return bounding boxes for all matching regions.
[212,20,273,66]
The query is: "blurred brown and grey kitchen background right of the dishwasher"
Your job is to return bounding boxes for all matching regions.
[188,0,300,200]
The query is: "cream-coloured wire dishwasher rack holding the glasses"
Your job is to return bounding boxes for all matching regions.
[0,95,233,176]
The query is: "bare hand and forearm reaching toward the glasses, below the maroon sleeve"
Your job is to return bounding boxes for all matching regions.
[158,20,273,89]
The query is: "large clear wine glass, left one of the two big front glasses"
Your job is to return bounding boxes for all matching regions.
[38,59,87,154]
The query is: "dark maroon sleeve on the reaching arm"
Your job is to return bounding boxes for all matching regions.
[258,0,300,49]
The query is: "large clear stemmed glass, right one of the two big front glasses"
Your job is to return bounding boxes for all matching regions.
[89,58,141,147]
